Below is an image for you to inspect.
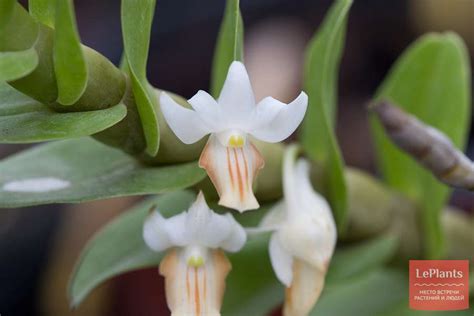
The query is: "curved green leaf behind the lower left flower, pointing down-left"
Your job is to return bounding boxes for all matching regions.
[69,191,195,307]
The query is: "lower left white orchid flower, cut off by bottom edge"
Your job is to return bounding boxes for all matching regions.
[143,193,247,316]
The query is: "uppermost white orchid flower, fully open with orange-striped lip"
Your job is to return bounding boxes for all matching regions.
[160,61,308,212]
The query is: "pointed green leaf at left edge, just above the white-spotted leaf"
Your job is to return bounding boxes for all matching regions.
[0,83,127,143]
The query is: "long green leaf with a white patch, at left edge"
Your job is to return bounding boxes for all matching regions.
[0,138,205,207]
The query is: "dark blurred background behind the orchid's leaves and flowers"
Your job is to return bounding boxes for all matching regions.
[0,0,474,316]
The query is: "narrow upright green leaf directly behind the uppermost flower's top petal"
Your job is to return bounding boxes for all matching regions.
[211,0,244,98]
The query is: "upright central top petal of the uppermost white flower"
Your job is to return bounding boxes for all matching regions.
[218,61,255,128]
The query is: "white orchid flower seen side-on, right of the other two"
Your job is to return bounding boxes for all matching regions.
[257,146,337,316]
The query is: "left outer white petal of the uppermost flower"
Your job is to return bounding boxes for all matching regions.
[160,92,211,144]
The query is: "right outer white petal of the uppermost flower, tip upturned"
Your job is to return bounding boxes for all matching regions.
[249,92,308,143]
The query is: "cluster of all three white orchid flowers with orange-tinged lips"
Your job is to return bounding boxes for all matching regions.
[143,61,336,316]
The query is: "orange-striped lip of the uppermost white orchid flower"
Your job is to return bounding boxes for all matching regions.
[199,135,264,212]
